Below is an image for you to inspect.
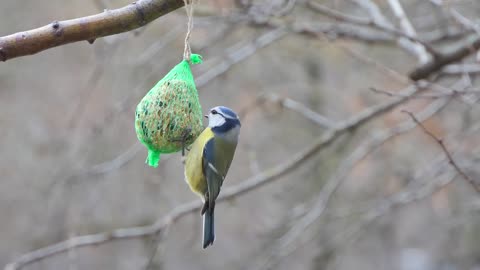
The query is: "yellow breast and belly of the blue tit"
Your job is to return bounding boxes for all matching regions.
[185,127,214,198]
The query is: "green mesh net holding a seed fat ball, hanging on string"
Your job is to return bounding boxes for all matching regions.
[135,54,203,167]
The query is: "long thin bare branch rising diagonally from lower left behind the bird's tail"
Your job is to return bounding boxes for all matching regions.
[4,81,423,270]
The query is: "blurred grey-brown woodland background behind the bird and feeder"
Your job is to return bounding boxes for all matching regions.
[0,0,480,270]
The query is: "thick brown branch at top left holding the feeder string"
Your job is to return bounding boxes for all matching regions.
[0,0,184,62]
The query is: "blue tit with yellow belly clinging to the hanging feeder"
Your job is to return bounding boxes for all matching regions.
[185,106,241,248]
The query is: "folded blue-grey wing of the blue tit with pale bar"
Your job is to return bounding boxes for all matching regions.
[203,138,226,209]
